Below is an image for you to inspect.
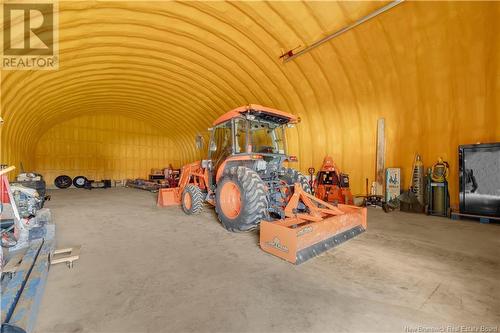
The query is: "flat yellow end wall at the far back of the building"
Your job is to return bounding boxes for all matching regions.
[35,115,180,184]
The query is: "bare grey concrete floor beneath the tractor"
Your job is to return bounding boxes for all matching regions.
[37,188,500,333]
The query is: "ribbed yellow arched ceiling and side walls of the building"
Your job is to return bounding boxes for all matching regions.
[1,1,500,202]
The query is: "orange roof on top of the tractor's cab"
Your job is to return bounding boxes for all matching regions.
[214,104,299,126]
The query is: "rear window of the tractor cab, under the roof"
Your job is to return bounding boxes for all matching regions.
[249,120,285,155]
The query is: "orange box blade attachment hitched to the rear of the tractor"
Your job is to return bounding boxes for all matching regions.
[260,184,366,264]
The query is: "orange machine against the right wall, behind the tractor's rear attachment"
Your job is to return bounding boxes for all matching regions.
[312,156,354,205]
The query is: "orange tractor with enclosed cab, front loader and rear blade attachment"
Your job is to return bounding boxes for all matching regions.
[158,105,366,264]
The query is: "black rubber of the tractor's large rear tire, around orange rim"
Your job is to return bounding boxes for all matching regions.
[215,166,269,232]
